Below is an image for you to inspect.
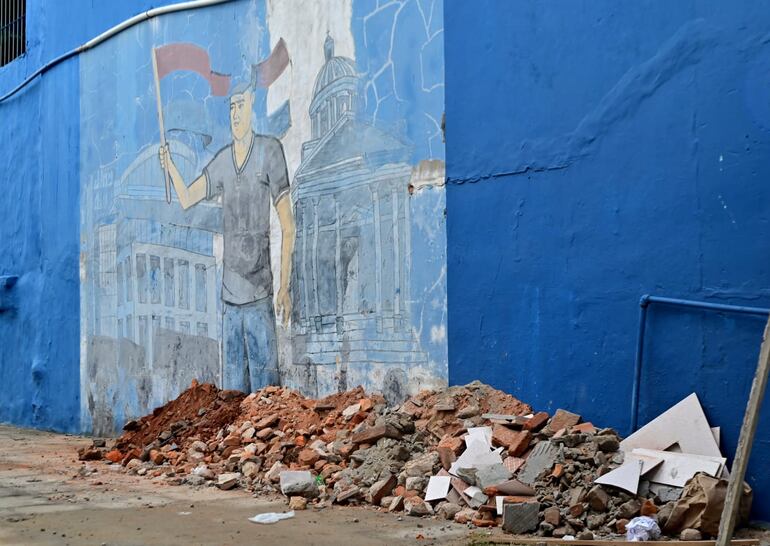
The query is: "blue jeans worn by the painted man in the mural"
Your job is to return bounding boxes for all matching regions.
[222,297,279,392]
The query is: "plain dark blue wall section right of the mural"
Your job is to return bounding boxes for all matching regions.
[445,0,770,520]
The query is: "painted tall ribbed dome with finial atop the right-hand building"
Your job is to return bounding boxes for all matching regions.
[309,36,358,139]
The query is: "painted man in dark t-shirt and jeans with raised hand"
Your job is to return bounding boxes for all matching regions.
[160,84,295,392]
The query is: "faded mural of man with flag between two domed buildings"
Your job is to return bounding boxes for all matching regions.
[80,0,447,432]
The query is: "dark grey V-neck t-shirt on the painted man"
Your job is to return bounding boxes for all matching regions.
[203,131,289,305]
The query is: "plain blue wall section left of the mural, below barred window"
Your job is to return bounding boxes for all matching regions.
[0,0,176,431]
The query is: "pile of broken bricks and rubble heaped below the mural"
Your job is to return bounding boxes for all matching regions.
[80,382,748,539]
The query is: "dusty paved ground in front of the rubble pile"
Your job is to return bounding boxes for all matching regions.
[0,426,486,546]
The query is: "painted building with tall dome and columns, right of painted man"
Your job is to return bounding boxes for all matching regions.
[292,36,427,397]
